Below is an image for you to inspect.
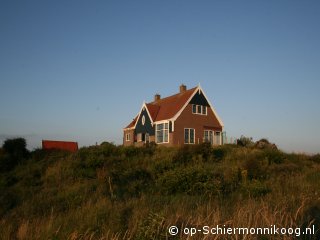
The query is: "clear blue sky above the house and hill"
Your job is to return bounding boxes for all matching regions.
[0,0,320,153]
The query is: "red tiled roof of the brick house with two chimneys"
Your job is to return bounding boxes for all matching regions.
[125,87,197,128]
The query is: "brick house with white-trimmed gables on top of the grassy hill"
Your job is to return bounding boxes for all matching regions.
[123,85,223,146]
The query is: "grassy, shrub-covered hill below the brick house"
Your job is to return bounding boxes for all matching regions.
[0,138,320,239]
